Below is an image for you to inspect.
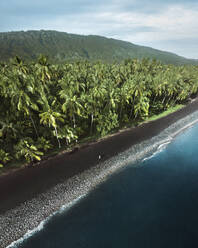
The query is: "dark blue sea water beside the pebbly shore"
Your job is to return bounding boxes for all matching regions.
[17,125,198,248]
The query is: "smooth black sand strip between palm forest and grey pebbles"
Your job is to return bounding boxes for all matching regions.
[0,100,198,248]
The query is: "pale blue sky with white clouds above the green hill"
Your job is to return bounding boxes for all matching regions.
[0,0,198,59]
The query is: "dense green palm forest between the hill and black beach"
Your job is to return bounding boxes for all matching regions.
[0,56,198,168]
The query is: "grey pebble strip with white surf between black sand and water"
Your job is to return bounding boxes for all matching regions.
[3,111,198,248]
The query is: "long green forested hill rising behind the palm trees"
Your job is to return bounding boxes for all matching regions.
[0,30,198,64]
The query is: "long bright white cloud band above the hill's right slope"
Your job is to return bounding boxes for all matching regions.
[41,6,198,41]
